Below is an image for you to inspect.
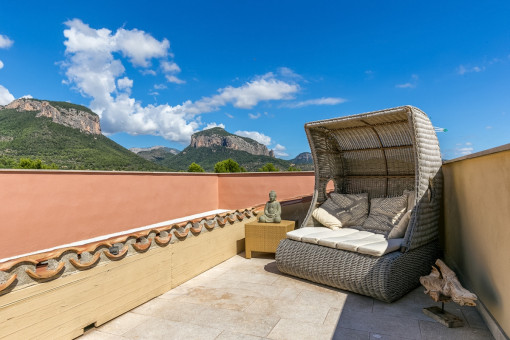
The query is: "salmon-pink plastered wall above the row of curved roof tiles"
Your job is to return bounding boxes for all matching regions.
[0,170,314,259]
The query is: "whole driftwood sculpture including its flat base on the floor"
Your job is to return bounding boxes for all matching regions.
[420,259,477,327]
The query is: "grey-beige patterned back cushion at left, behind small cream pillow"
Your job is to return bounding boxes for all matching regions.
[319,193,368,227]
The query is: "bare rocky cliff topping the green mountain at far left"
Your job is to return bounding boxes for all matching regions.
[0,98,101,135]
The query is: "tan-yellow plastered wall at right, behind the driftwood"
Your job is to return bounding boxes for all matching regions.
[443,144,510,336]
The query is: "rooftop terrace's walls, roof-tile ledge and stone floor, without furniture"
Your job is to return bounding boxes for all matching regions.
[0,145,510,340]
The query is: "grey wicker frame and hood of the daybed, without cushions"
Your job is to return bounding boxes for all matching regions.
[276,106,442,302]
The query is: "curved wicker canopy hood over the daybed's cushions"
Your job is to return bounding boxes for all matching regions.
[302,106,442,249]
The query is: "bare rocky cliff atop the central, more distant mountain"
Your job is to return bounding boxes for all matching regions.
[190,128,274,157]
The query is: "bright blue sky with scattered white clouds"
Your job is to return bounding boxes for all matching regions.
[0,1,510,159]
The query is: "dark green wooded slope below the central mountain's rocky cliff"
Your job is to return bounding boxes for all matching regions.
[163,146,290,172]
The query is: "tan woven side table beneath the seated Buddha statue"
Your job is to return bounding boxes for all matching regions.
[245,220,296,259]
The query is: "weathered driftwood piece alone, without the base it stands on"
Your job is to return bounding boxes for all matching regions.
[420,259,477,306]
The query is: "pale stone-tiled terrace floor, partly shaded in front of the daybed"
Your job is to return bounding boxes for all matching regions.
[79,254,492,340]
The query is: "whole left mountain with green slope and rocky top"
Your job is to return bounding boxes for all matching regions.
[0,100,168,171]
